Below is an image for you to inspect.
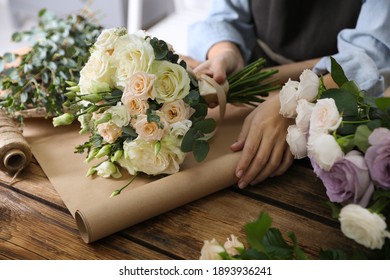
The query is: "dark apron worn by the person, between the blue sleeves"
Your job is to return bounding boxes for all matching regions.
[250,0,362,66]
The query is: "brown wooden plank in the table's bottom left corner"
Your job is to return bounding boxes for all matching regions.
[0,187,169,259]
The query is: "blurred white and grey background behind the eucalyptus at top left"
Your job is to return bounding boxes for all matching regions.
[0,0,211,55]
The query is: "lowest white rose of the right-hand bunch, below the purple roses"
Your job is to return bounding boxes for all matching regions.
[339,204,390,249]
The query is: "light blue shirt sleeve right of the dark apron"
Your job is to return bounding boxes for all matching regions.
[313,0,390,97]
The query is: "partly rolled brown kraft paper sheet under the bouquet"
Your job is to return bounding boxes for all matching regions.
[24,106,250,243]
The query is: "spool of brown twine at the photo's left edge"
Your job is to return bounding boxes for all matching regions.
[0,110,32,174]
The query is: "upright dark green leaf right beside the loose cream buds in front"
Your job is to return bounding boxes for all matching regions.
[245,212,272,253]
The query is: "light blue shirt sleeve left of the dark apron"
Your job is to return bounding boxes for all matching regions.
[187,0,256,61]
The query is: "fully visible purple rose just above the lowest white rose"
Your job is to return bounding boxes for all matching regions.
[311,150,374,207]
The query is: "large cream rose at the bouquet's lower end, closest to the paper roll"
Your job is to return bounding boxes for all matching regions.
[118,139,179,175]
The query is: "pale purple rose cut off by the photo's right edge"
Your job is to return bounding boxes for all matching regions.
[364,127,390,189]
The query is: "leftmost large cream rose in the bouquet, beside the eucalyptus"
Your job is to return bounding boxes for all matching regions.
[79,51,112,94]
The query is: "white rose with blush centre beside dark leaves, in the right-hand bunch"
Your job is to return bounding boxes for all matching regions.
[310,98,342,134]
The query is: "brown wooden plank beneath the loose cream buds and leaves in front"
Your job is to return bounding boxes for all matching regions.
[125,190,361,259]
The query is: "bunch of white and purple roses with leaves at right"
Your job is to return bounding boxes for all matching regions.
[280,58,390,252]
